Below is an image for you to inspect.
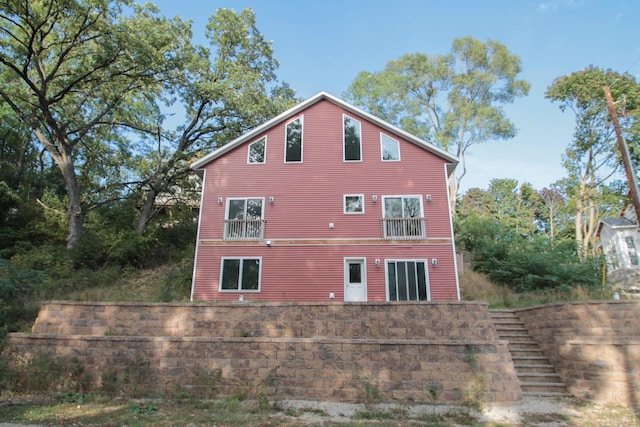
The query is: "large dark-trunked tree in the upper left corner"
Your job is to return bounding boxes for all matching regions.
[0,0,191,247]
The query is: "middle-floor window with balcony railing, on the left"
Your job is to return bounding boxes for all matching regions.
[224,198,264,240]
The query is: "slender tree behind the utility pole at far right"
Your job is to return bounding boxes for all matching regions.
[546,67,640,261]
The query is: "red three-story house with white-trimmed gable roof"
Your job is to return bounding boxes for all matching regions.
[191,92,460,302]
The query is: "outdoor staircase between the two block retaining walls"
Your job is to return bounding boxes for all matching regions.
[490,310,567,396]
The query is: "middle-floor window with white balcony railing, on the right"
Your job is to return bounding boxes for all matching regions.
[382,196,426,239]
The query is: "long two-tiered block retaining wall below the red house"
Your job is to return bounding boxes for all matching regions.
[9,302,522,403]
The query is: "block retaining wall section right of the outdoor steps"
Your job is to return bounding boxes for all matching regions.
[517,301,640,408]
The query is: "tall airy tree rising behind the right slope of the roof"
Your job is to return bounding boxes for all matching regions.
[345,36,529,206]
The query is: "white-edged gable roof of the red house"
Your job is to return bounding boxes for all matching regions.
[190,92,458,175]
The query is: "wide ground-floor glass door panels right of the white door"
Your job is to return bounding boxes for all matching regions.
[387,260,430,301]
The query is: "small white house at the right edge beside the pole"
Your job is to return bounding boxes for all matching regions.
[598,216,640,274]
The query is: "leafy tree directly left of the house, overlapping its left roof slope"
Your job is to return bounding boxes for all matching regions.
[137,9,295,234]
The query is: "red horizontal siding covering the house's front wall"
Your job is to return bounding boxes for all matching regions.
[194,100,457,301]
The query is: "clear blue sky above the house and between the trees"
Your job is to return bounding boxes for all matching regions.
[152,0,640,192]
